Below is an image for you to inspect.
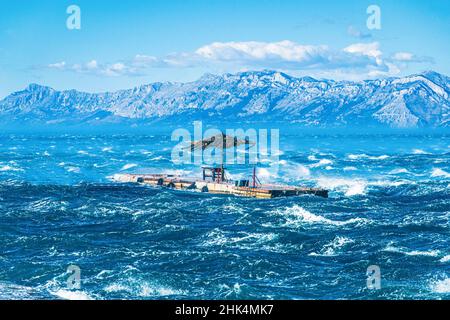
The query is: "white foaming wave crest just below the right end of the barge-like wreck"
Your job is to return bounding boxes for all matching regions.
[274,205,367,226]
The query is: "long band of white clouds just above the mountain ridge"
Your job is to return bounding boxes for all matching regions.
[48,40,432,78]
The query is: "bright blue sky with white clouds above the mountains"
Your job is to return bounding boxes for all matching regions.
[0,0,450,97]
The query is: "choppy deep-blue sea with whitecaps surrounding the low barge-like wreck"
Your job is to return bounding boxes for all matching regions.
[0,130,450,299]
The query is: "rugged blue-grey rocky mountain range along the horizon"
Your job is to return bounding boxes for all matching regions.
[0,71,450,128]
